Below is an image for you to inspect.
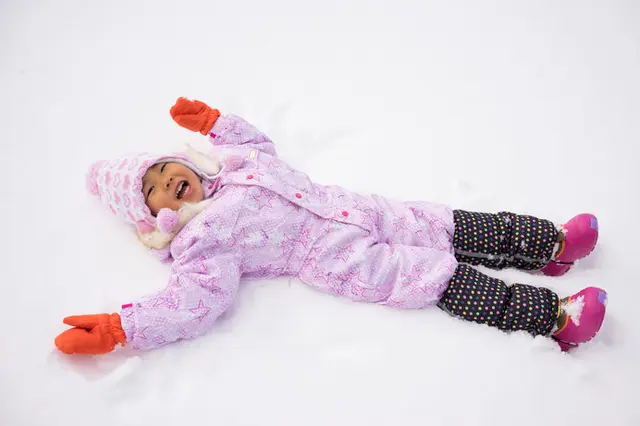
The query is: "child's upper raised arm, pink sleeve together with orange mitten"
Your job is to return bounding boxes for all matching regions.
[171,98,276,155]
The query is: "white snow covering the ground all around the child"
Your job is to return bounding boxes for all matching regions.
[0,0,640,426]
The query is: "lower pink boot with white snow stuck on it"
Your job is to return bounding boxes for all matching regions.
[551,287,607,352]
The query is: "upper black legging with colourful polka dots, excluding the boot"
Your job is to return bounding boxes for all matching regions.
[453,210,559,270]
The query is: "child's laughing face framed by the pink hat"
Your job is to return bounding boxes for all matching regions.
[142,162,204,216]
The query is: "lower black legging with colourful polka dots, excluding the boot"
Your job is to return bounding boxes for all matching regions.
[438,265,558,335]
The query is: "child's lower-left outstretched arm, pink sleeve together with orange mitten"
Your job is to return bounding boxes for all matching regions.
[55,253,240,354]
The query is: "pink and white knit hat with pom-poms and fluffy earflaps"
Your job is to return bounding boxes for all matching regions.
[86,145,241,249]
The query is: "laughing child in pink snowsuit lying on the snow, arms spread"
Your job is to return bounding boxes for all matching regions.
[55,98,607,354]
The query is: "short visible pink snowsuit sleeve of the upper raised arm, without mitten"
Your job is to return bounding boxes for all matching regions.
[208,115,277,156]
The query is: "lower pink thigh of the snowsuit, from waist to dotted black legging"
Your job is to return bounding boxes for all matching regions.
[298,221,458,309]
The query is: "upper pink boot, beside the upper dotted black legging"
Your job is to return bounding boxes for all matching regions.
[541,213,598,277]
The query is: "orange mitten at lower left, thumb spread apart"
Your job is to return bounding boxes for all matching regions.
[56,314,127,354]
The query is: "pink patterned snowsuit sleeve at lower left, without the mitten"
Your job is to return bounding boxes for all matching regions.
[120,252,240,350]
